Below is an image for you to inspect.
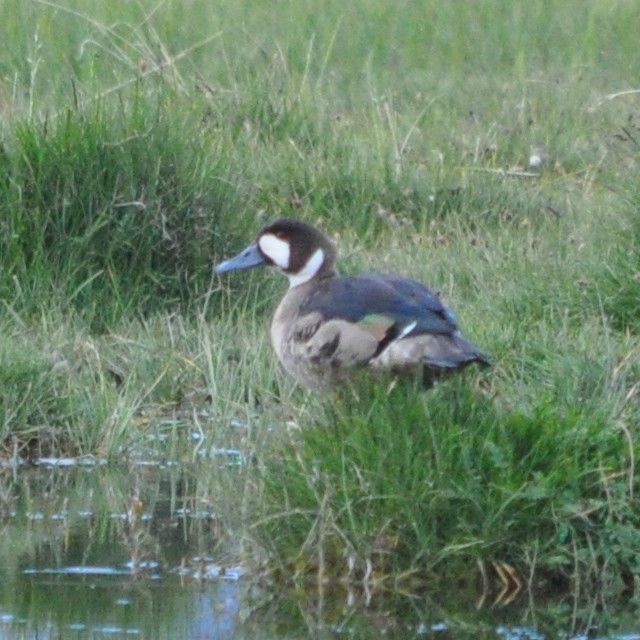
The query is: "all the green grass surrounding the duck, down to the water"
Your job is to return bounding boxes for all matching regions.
[0,0,640,591]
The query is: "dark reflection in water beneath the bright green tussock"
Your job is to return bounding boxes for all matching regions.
[258,584,637,638]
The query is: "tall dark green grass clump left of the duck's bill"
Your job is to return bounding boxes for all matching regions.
[2,94,246,329]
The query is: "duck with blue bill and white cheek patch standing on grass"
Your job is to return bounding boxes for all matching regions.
[214,218,491,392]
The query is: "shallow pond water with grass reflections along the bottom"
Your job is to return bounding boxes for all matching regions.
[0,464,640,640]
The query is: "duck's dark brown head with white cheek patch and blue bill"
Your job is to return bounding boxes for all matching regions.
[214,218,336,287]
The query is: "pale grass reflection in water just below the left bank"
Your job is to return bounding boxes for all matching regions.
[0,466,242,580]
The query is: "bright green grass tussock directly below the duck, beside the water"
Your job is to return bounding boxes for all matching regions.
[255,362,640,586]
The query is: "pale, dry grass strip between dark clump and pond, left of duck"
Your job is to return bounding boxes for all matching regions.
[0,296,293,462]
